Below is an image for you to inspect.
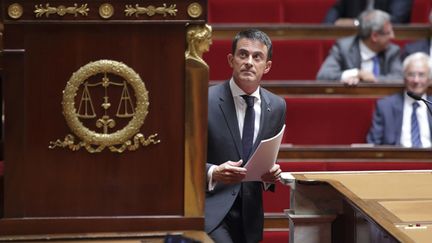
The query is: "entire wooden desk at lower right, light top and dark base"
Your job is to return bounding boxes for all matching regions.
[283,170,432,243]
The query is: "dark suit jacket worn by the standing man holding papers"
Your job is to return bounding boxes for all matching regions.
[205,82,286,242]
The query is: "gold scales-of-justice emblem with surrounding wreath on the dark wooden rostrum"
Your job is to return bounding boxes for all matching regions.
[49,60,160,153]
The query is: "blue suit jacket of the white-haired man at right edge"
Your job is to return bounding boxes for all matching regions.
[366,92,432,145]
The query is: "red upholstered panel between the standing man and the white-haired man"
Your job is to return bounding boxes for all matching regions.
[282,97,376,145]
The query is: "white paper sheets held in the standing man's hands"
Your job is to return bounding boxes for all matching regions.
[243,125,285,181]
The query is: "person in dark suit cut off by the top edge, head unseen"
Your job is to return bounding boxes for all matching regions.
[324,0,412,26]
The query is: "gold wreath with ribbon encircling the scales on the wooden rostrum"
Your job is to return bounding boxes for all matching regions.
[49,60,160,153]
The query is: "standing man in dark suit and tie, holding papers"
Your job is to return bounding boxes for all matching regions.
[205,29,286,243]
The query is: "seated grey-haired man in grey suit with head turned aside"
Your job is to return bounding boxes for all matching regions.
[317,10,403,85]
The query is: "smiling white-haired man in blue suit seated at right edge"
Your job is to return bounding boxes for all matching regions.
[367,52,432,147]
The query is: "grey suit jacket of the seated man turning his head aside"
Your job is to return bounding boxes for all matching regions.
[317,36,403,83]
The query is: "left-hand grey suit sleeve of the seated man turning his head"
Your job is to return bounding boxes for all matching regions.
[316,42,344,81]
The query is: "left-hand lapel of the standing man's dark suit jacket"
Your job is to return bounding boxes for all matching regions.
[219,82,243,158]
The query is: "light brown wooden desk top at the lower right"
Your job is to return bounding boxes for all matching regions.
[292,171,432,243]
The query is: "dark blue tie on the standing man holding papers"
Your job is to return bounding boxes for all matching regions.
[242,95,255,163]
